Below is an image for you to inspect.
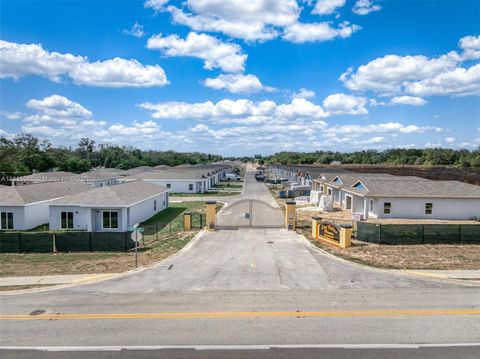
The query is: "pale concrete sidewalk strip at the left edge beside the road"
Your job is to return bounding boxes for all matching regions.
[0,273,117,287]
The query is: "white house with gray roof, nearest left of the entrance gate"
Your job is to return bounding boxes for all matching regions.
[49,180,168,232]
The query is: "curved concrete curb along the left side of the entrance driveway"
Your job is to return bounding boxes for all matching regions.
[0,229,206,297]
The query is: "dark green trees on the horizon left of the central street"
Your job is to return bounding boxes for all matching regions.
[0,134,222,174]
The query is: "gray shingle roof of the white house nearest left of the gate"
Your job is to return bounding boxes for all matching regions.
[52,180,168,207]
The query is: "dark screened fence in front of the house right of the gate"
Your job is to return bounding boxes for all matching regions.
[356,222,480,244]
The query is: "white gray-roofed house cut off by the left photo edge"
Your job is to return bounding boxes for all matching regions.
[0,181,92,230]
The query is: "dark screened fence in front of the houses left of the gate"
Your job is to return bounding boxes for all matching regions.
[0,231,135,253]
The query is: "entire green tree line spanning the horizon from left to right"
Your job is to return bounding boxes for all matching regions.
[0,134,480,173]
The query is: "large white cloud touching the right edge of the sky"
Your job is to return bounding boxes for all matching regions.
[340,36,480,97]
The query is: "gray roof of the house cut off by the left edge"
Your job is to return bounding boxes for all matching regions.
[0,181,92,206]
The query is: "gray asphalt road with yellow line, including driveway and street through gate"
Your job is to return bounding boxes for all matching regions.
[0,166,480,358]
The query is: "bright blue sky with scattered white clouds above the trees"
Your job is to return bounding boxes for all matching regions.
[0,0,480,155]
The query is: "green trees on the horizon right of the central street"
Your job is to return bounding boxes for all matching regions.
[263,147,480,168]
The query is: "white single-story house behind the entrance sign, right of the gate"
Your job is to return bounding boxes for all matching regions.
[315,173,480,220]
